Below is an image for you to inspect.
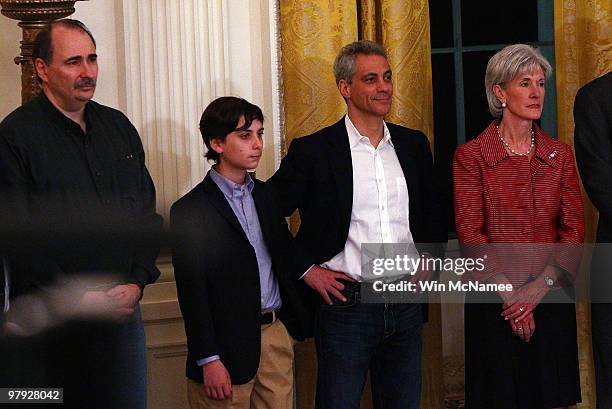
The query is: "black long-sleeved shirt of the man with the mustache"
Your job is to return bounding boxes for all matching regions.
[0,93,161,296]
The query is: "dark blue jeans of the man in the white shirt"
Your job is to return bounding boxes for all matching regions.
[315,285,423,409]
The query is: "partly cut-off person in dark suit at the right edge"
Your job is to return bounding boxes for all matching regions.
[574,72,612,409]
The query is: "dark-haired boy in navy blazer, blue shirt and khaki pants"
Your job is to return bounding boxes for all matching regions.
[170,97,312,409]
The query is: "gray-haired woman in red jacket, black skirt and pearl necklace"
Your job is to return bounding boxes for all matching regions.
[453,44,584,409]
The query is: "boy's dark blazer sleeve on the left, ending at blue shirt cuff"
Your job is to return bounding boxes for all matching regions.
[170,205,221,359]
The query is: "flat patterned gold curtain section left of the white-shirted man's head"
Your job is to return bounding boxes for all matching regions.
[280,0,357,147]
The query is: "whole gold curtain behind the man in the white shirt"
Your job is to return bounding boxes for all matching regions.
[280,0,443,409]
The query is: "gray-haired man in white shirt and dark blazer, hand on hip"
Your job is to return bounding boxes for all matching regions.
[270,41,446,409]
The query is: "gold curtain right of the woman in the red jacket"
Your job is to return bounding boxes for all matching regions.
[554,0,612,409]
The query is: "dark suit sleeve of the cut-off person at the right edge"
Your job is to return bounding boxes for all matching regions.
[574,82,612,219]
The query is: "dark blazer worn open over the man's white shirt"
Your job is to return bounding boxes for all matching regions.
[268,117,447,316]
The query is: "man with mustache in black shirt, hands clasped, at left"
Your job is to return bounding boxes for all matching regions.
[0,19,161,409]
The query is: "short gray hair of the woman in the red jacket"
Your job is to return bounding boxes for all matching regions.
[485,44,552,118]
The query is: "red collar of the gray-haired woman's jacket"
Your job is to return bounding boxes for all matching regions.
[480,121,559,166]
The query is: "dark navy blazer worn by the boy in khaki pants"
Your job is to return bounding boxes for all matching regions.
[170,175,311,384]
